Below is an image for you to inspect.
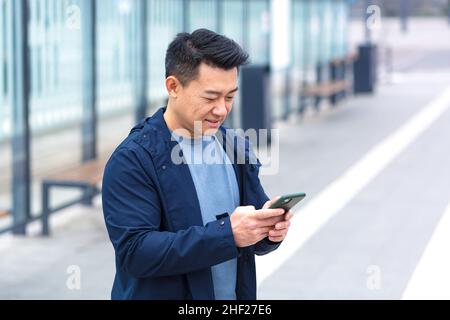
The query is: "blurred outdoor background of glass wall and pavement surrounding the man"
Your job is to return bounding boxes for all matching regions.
[0,0,450,299]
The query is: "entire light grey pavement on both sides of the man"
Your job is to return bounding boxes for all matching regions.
[0,16,450,299]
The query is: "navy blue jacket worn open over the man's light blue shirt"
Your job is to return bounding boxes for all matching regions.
[102,108,279,300]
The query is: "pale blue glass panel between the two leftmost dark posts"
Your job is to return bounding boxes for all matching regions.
[29,0,81,133]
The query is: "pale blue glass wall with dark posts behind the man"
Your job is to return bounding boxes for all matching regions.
[0,0,349,234]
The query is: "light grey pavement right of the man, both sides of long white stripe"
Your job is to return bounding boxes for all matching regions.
[259,74,450,299]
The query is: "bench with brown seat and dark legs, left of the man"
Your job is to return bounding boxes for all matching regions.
[42,159,106,236]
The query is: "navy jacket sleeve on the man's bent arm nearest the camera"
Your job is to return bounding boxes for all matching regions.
[102,148,238,278]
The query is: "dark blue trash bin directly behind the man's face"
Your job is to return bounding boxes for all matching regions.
[240,65,272,145]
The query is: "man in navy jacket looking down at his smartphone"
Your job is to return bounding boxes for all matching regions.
[102,29,292,300]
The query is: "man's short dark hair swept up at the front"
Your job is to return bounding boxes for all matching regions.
[166,29,248,86]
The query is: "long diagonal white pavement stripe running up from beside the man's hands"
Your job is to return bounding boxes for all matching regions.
[256,86,450,284]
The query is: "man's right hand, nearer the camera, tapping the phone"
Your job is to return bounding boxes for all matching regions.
[230,206,284,248]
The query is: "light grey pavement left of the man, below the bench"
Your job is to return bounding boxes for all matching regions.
[0,198,115,299]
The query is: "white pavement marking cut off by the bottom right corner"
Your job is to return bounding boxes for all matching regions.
[403,203,450,300]
